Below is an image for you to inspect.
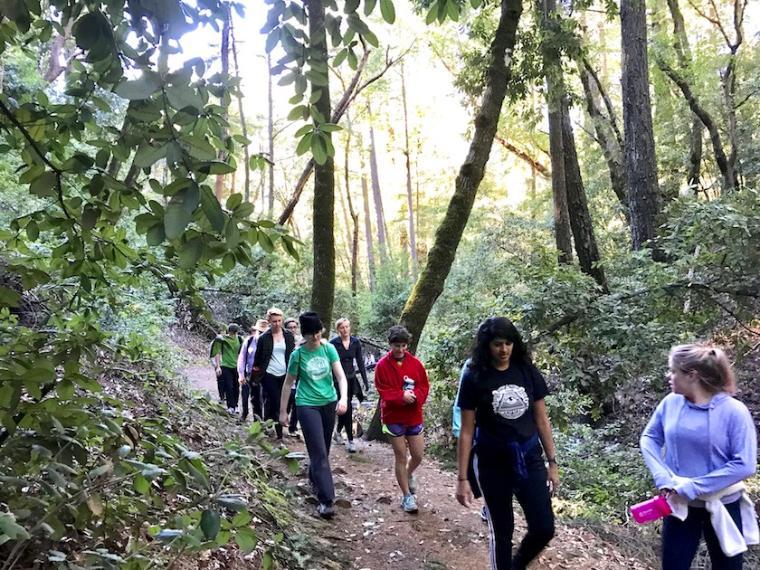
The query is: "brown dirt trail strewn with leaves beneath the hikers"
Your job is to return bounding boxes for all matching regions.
[175,328,652,570]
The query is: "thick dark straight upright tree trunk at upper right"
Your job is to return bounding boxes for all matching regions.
[620,0,661,251]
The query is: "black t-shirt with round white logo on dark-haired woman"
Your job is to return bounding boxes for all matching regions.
[458,363,549,443]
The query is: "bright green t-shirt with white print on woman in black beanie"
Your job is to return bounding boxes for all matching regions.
[288,343,340,406]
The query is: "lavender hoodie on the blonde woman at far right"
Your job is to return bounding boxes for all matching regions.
[639,392,757,502]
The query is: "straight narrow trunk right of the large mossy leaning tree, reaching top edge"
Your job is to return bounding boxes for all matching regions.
[540,0,573,263]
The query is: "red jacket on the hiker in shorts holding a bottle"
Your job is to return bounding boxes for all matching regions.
[375,352,430,426]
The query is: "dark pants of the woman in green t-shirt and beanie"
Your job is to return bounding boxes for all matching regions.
[296,402,337,505]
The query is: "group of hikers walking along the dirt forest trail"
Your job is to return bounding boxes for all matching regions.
[212,309,760,570]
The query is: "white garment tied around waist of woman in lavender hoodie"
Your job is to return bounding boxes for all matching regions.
[668,476,760,557]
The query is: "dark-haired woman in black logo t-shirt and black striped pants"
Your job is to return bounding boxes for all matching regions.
[456,317,559,570]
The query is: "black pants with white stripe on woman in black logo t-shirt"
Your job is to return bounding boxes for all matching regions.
[473,445,554,570]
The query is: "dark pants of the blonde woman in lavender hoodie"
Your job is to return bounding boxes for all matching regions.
[662,501,743,570]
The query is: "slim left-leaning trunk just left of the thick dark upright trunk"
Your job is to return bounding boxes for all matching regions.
[578,59,630,216]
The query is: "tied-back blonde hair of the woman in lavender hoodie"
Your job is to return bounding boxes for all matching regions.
[670,343,736,395]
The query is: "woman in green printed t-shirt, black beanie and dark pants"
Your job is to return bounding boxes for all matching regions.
[280,311,347,519]
